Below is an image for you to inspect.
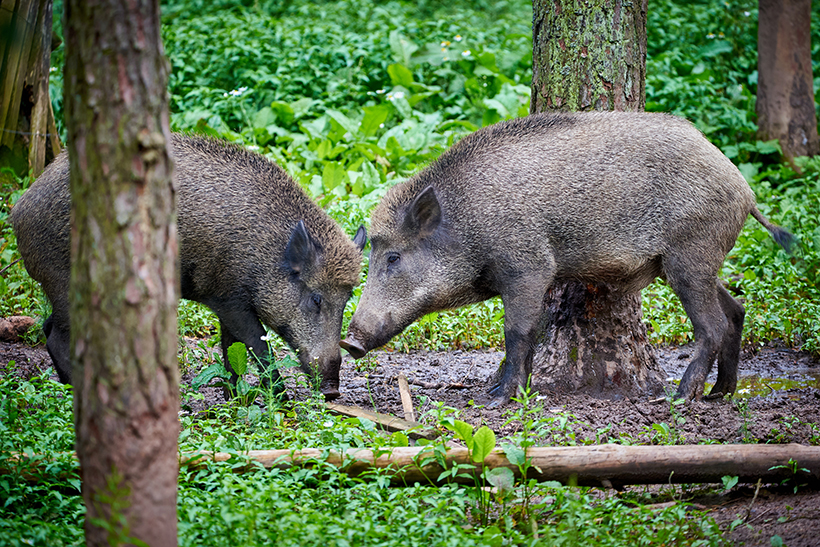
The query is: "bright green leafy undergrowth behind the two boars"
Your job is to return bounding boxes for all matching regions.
[0,0,820,353]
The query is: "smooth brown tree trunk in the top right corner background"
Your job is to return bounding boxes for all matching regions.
[757,0,820,159]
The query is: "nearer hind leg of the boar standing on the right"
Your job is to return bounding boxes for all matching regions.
[667,273,729,399]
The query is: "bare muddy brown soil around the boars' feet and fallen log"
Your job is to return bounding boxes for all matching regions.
[0,340,820,547]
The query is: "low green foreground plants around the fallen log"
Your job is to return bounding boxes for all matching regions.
[0,370,732,546]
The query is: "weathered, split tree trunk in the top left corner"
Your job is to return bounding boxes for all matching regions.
[0,0,60,176]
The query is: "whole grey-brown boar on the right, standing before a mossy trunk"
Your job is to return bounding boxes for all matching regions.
[342,112,794,402]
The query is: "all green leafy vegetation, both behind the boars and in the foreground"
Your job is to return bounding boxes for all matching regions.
[0,0,820,545]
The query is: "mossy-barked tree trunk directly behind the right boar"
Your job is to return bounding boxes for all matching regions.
[530,0,662,396]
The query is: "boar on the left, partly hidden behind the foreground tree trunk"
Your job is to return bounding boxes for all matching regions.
[11,135,366,399]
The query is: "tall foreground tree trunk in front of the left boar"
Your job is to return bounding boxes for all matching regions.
[65,0,179,547]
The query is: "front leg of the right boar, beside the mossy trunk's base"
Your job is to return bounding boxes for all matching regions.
[490,274,552,407]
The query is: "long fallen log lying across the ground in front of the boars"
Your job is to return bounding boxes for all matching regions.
[180,444,820,486]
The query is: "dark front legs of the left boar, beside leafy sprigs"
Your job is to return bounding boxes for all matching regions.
[216,309,284,393]
